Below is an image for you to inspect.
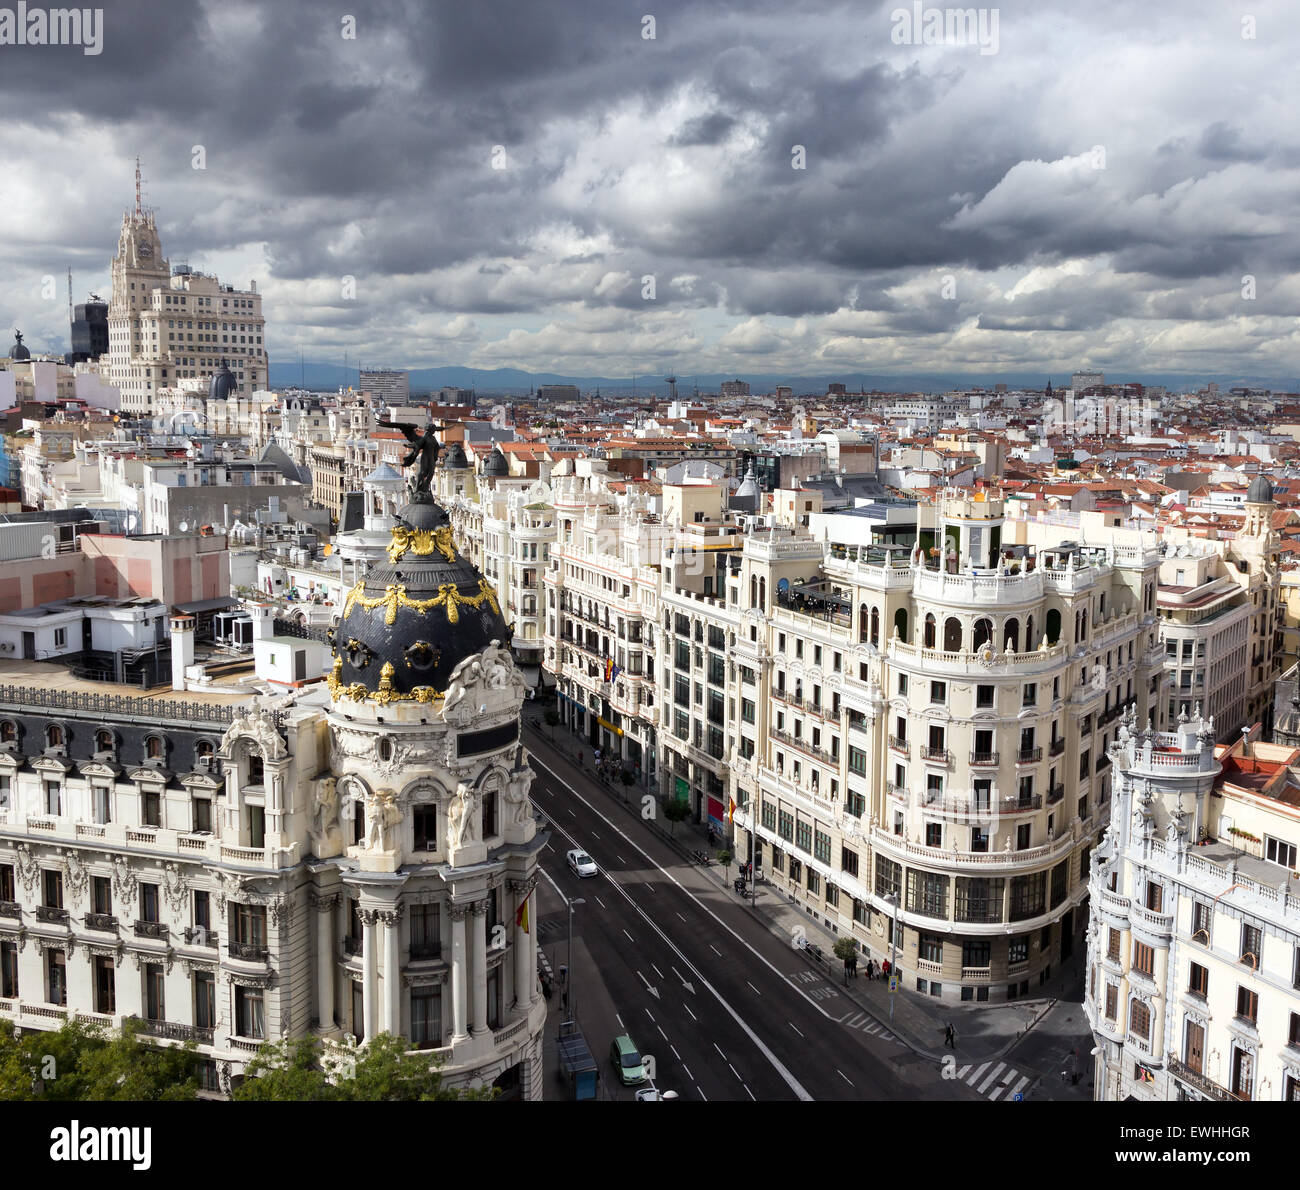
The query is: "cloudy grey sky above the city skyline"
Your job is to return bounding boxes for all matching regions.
[0,0,1300,381]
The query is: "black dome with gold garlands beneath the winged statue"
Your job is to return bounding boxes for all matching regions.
[329,498,510,702]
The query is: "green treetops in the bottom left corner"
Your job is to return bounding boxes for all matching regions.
[0,1018,199,1103]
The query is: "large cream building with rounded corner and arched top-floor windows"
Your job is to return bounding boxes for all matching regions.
[733,492,1164,1000]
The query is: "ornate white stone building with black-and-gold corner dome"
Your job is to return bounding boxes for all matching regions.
[0,465,545,1099]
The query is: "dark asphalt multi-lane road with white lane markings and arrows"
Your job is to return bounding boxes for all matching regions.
[533,752,969,1102]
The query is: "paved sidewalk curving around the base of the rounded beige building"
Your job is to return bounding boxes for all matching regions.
[524,719,1091,1071]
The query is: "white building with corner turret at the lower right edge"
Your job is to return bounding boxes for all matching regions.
[1084,717,1300,1102]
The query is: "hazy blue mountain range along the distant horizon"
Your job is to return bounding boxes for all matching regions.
[270,363,1300,398]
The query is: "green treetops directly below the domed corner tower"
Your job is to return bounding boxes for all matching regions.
[231,1033,497,1103]
